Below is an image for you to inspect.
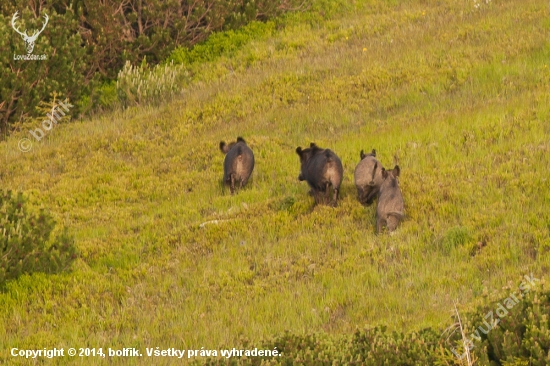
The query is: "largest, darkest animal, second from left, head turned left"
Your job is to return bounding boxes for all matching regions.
[296,142,344,206]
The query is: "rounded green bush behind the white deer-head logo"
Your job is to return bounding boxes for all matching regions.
[0,4,87,132]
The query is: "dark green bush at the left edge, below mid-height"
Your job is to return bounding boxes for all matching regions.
[0,191,76,285]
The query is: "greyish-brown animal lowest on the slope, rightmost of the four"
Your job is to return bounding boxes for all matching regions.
[376,165,405,233]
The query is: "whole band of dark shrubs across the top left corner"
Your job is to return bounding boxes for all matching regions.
[0,0,309,132]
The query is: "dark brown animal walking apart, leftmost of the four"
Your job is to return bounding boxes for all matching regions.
[220,136,254,194]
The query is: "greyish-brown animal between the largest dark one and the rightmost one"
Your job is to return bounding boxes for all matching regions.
[354,149,384,205]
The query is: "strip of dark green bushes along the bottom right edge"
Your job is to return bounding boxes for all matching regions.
[203,280,550,366]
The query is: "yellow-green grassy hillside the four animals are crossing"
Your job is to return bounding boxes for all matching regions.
[0,0,550,364]
